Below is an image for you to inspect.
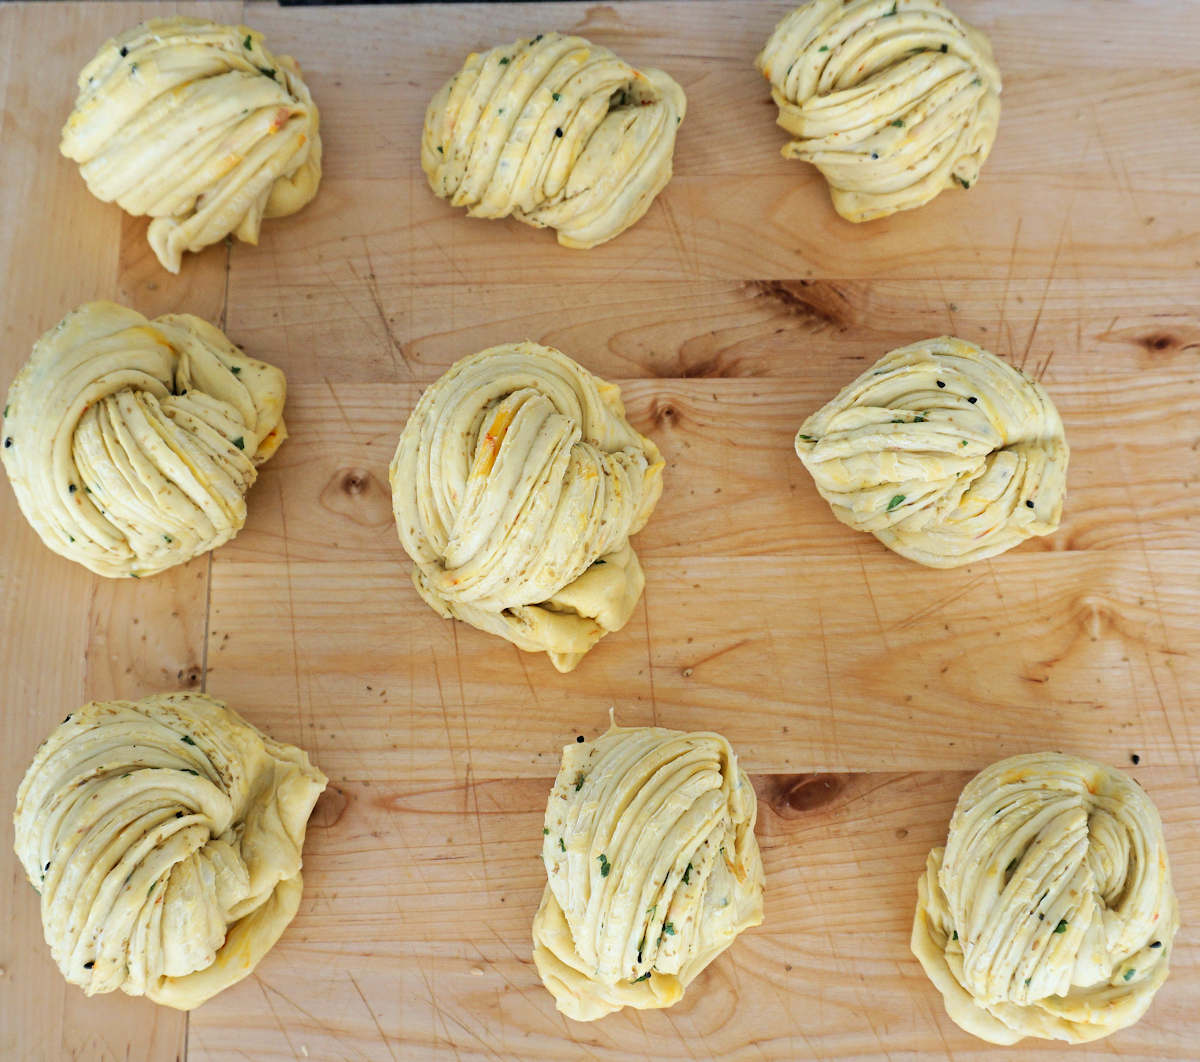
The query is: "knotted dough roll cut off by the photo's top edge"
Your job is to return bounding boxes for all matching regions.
[757,0,1001,221]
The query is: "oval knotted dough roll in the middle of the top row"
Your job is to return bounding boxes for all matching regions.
[421,34,688,248]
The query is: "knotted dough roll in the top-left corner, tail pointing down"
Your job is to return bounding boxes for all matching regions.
[61,16,320,272]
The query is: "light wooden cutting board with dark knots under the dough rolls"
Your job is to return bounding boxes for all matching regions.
[0,0,1200,1062]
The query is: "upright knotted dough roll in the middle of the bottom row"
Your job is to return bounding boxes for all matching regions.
[533,725,763,1021]
